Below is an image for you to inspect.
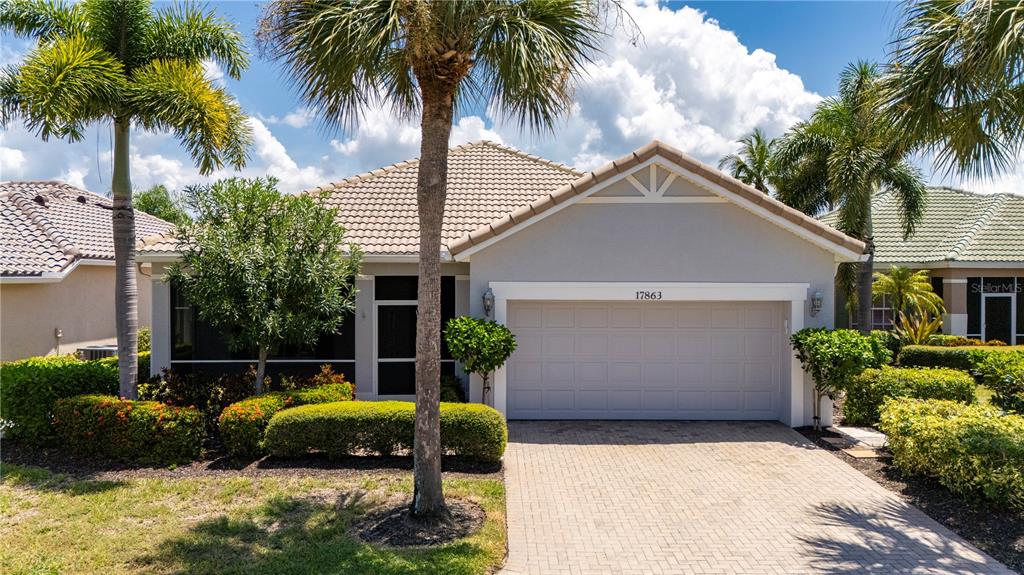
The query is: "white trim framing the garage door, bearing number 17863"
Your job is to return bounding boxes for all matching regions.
[487,281,810,426]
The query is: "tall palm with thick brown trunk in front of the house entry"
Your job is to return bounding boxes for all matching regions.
[259,0,601,518]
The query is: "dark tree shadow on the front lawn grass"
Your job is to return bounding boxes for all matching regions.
[134,487,486,575]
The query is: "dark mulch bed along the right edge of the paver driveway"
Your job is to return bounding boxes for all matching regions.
[797,428,1024,574]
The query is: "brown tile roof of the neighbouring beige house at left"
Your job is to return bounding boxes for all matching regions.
[0,181,172,276]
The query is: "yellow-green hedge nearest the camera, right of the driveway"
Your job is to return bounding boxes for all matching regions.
[879,398,1024,511]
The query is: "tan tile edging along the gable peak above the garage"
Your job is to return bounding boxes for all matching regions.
[449,140,864,255]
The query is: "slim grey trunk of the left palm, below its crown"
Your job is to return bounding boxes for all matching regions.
[111,119,138,399]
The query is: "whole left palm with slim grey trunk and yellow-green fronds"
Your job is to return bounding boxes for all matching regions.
[0,0,250,399]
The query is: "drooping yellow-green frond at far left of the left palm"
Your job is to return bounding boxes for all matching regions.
[0,35,125,141]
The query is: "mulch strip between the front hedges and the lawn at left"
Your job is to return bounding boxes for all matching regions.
[0,439,502,481]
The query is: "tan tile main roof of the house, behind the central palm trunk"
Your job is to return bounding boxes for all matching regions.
[309,141,581,255]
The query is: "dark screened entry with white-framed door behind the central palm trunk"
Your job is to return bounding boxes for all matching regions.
[374,275,455,395]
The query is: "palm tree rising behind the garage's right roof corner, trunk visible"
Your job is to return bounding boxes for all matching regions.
[778,62,926,333]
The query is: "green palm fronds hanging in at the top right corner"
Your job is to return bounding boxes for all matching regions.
[880,0,1024,176]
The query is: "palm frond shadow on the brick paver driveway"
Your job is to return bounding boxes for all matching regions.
[800,501,1010,575]
